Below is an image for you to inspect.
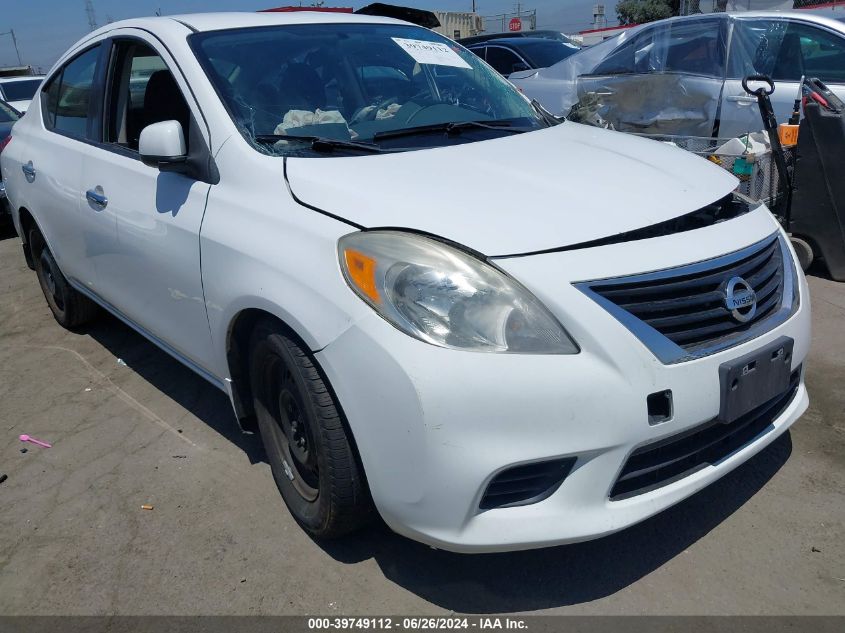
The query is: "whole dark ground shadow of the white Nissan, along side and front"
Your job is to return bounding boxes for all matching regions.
[79,316,792,613]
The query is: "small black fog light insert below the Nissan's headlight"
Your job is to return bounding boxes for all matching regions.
[478,457,575,510]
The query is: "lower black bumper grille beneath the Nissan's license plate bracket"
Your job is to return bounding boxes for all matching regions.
[610,367,801,501]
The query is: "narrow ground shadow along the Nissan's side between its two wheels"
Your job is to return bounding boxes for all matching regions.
[80,313,266,464]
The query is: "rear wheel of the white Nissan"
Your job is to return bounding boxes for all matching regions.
[29,230,99,329]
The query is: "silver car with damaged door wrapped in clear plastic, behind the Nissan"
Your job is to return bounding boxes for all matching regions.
[509,11,845,137]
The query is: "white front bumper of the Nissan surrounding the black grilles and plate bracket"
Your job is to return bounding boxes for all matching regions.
[317,210,810,552]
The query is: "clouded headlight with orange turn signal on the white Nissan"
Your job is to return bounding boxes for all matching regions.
[338,231,578,354]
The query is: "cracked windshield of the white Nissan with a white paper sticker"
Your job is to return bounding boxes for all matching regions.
[191,24,551,156]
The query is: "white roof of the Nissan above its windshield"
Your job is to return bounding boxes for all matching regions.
[97,11,410,33]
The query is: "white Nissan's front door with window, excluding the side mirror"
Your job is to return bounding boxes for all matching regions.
[82,29,212,368]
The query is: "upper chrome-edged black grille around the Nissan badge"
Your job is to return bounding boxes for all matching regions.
[578,235,794,362]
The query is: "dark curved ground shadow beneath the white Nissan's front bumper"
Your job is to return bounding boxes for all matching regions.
[318,433,792,614]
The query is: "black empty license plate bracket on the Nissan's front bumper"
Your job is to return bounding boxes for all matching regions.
[719,336,795,424]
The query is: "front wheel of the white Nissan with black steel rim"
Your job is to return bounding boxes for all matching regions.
[249,320,372,538]
